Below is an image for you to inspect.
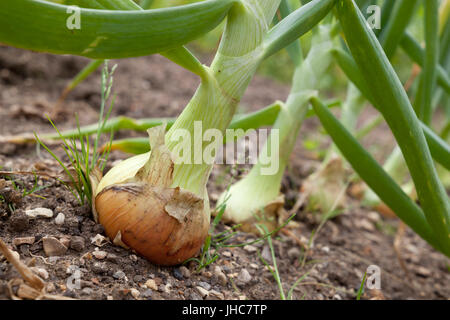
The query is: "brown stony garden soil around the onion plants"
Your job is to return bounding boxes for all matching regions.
[0,47,450,300]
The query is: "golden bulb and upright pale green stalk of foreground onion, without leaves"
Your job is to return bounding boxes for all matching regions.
[91,0,279,265]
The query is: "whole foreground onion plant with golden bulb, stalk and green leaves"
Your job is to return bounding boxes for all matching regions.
[0,0,335,265]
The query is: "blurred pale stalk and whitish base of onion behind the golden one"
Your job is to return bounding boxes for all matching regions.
[218,25,332,232]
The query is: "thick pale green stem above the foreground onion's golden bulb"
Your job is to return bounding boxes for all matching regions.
[166,0,281,196]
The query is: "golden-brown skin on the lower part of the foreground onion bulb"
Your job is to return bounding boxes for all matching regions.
[95,183,209,266]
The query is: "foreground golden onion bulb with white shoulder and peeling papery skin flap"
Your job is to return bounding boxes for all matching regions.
[93,126,210,265]
